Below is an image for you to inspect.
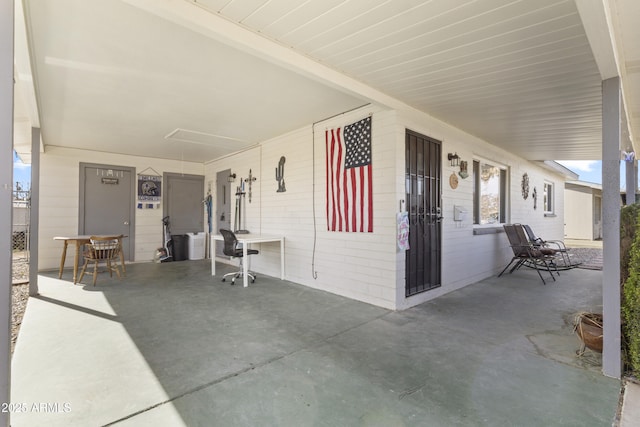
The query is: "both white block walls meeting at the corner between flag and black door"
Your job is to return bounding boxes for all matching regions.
[205,107,564,309]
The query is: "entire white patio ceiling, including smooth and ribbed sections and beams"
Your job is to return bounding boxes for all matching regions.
[15,0,640,162]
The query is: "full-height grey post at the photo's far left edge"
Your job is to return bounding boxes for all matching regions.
[0,0,13,426]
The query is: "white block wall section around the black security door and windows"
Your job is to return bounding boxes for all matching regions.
[396,111,564,309]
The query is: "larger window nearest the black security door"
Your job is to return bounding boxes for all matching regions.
[473,160,507,225]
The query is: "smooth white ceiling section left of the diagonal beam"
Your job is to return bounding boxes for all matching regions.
[21,0,366,161]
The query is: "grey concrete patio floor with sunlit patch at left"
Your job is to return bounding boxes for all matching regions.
[11,261,620,427]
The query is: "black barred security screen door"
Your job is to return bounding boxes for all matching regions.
[405,130,442,296]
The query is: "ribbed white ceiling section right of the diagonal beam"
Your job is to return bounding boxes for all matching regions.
[202,0,601,159]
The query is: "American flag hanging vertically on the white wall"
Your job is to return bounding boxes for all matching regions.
[325,116,373,233]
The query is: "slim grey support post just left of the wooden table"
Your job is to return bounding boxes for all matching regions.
[29,128,40,296]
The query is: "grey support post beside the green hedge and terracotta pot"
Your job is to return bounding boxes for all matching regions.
[602,77,624,378]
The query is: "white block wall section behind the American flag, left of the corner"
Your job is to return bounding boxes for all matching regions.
[205,108,396,308]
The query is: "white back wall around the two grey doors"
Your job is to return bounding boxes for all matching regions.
[38,147,203,270]
